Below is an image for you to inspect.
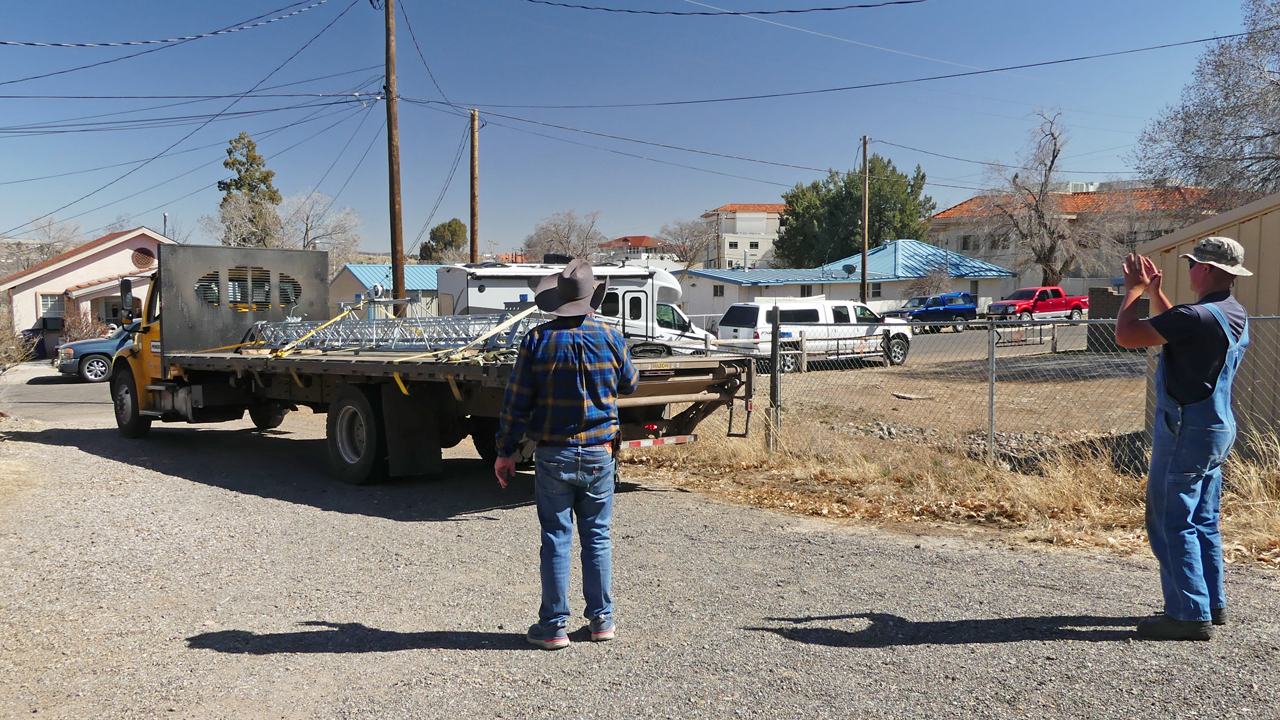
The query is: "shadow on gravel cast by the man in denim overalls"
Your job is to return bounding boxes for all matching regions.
[745,612,1140,647]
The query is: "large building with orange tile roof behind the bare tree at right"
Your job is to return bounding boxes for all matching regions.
[929,182,1210,295]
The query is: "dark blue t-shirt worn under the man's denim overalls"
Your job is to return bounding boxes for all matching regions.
[1151,290,1249,405]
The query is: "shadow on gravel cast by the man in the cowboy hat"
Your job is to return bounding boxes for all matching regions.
[187,620,536,655]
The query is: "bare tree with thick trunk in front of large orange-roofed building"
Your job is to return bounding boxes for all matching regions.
[983,113,1116,286]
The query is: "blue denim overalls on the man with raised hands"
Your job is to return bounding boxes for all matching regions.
[1147,304,1249,621]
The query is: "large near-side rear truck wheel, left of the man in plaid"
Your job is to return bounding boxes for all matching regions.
[325,386,387,486]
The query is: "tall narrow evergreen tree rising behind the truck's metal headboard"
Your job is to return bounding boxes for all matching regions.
[216,132,282,247]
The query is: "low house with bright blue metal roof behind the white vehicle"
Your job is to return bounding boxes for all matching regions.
[676,240,1016,322]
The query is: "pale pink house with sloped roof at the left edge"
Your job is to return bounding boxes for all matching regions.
[0,227,173,351]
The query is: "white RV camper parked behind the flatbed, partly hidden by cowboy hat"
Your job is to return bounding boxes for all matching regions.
[436,263,710,346]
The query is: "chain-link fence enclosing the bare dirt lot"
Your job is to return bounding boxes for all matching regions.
[699,318,1280,474]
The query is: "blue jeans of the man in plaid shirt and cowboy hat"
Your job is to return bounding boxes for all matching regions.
[534,446,616,628]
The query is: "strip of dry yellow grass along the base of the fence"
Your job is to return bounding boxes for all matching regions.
[623,418,1280,565]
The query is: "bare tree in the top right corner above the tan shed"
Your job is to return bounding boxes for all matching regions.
[1134,0,1280,196]
